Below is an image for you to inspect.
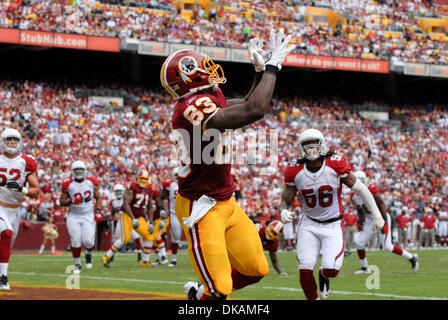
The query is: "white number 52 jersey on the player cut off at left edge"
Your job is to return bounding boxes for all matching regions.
[0,153,37,205]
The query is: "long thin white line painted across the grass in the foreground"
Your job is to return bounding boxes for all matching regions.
[9,272,448,300]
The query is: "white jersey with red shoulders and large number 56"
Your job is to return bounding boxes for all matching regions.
[285,155,351,221]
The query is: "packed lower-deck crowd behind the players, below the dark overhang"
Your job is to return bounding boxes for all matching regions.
[0,81,448,249]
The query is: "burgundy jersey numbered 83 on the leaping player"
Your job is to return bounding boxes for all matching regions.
[172,88,235,200]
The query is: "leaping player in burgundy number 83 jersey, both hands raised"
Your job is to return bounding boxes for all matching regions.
[160,29,294,300]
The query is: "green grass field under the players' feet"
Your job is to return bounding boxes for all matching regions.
[8,250,448,300]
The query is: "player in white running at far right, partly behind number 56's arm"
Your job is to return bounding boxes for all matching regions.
[352,171,418,274]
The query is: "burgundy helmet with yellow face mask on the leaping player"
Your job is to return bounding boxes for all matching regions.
[160,49,226,100]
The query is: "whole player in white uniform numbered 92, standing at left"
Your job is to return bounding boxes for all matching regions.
[59,160,102,272]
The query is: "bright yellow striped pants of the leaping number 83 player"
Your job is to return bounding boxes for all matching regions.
[175,194,269,296]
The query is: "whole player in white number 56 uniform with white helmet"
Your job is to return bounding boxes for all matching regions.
[280,129,384,300]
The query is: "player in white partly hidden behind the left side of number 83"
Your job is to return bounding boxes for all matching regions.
[160,168,182,267]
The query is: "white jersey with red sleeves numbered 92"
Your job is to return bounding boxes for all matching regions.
[62,177,98,216]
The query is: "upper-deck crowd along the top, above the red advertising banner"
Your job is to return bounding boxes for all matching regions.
[0,0,448,64]
